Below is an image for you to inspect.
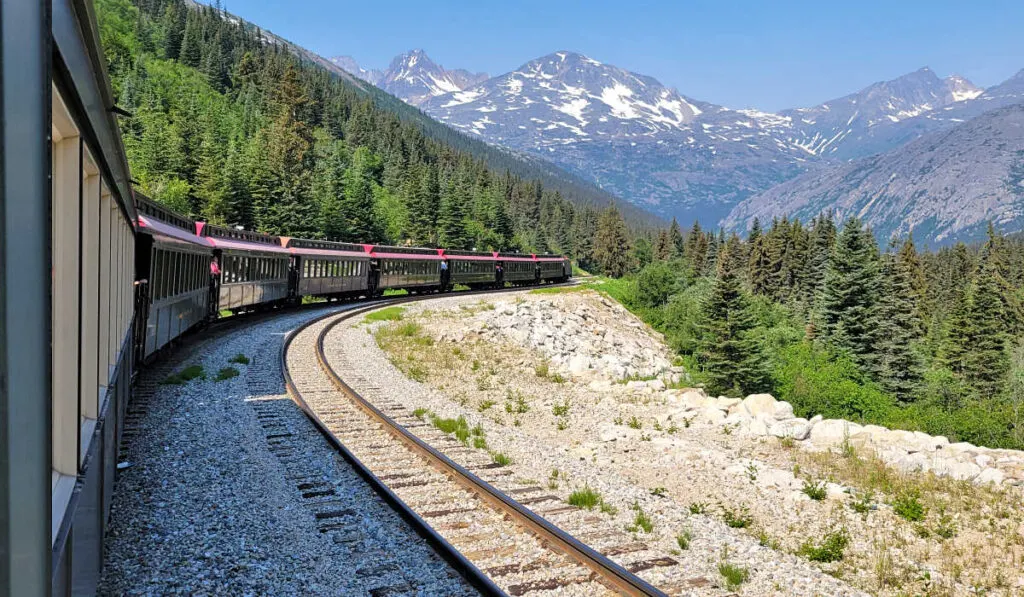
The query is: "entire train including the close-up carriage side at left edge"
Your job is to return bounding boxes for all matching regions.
[12,0,571,596]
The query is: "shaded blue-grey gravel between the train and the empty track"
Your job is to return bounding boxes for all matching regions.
[99,310,475,595]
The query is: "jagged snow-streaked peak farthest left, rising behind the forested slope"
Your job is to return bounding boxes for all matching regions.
[331,50,487,105]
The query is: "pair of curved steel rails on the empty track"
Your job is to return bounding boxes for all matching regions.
[282,289,665,596]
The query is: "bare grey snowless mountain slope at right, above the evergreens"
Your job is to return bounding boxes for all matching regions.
[724,98,1024,243]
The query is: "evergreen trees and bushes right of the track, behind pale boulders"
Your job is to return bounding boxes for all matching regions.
[594,210,1024,447]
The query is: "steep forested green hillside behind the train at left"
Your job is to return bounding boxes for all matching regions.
[97,0,601,259]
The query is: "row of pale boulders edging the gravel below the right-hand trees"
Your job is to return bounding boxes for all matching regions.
[648,389,1024,485]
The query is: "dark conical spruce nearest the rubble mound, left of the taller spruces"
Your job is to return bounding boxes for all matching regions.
[699,236,763,395]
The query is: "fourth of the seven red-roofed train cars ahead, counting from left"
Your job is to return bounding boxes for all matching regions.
[370,245,443,292]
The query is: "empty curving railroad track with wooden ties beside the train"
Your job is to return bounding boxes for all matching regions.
[282,296,675,596]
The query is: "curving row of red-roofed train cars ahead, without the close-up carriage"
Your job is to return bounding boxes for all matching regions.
[134,191,572,361]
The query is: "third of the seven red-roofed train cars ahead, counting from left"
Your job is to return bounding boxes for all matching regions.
[281,237,373,300]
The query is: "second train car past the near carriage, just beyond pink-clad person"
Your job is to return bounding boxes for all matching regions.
[196,222,291,311]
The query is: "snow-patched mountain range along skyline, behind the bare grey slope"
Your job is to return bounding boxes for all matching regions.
[348,51,1024,242]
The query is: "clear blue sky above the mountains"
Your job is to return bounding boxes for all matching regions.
[225,0,1024,110]
